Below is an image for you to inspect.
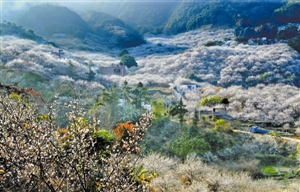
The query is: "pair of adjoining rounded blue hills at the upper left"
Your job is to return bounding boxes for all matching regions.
[13,4,144,47]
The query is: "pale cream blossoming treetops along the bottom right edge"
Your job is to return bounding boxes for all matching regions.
[138,155,299,192]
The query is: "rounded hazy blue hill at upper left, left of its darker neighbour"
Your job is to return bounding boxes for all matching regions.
[17,4,90,37]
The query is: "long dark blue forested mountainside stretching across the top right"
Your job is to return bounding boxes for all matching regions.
[94,0,300,35]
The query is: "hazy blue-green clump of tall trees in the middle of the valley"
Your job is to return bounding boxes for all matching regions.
[89,81,151,129]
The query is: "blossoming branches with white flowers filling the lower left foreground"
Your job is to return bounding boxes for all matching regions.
[0,86,151,192]
